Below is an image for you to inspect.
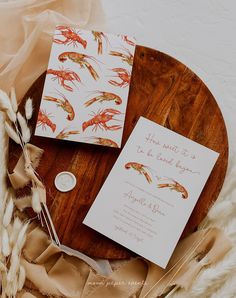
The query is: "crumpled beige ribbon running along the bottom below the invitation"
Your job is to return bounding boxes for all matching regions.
[19,226,231,298]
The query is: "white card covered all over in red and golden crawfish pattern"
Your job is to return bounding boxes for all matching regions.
[35,26,135,147]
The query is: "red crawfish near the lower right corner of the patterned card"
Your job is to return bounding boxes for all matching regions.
[82,109,122,131]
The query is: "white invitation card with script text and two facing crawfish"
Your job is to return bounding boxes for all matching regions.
[83,117,219,268]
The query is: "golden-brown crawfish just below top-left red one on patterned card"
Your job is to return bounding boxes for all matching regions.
[58,52,99,80]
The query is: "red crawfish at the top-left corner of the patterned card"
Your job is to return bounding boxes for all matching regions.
[53,26,87,49]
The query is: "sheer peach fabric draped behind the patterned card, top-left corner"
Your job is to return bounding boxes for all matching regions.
[0,0,103,98]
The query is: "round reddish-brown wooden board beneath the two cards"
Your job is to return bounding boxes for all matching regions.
[9,46,228,258]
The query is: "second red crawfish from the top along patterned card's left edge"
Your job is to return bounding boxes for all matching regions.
[47,68,81,91]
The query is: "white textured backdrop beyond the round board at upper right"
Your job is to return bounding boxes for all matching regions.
[98,0,236,157]
